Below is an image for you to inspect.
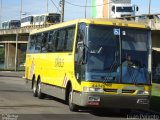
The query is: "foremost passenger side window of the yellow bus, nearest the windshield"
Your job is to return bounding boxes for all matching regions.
[64,26,75,51]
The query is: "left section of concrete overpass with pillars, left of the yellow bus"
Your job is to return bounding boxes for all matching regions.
[0,25,46,71]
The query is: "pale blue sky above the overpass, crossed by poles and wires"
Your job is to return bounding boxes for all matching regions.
[0,0,160,21]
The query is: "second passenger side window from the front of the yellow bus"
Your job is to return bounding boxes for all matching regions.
[57,29,66,51]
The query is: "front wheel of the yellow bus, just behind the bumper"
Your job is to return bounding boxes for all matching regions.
[68,88,79,112]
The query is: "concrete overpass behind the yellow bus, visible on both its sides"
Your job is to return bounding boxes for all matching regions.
[0,14,160,70]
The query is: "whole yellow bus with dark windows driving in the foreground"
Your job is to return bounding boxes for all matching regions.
[25,19,152,111]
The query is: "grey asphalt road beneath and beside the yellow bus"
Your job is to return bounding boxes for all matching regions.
[0,72,160,120]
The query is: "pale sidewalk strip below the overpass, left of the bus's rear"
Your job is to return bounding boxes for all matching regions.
[0,71,24,78]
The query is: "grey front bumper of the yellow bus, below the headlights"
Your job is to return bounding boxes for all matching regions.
[73,93,150,110]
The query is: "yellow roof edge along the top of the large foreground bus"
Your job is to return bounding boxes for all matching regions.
[30,18,149,35]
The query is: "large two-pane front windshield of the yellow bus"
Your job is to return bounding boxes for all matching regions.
[85,25,149,84]
